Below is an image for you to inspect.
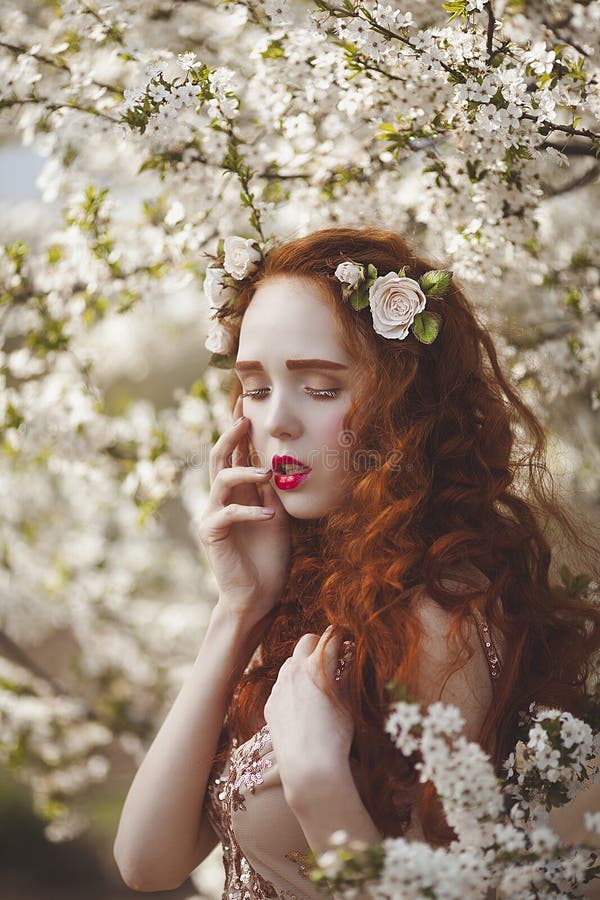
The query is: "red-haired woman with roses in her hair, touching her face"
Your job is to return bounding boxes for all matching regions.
[115,228,600,900]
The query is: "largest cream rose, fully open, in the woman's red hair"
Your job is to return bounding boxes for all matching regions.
[369,272,427,340]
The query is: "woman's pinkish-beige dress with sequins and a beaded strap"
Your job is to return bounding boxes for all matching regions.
[206,568,500,900]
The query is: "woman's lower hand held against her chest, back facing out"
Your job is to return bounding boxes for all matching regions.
[264,626,354,805]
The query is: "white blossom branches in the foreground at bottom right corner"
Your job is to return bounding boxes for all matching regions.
[302,686,600,900]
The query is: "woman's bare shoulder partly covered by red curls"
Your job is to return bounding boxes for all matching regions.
[412,591,493,740]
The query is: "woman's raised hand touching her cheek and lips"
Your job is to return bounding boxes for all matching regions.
[199,397,291,626]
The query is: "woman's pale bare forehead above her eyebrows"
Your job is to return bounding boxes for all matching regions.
[238,275,351,364]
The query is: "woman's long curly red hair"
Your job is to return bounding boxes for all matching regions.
[209,227,600,843]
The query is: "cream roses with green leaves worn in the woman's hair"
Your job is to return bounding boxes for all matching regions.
[204,235,452,368]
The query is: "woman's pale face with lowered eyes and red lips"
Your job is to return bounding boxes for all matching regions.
[234,275,356,519]
